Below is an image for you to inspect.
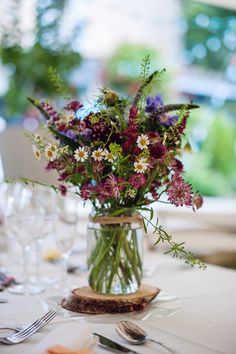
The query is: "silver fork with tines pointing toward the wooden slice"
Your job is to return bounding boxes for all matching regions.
[0,310,57,344]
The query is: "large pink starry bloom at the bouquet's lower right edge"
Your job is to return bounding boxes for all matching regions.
[167,176,192,206]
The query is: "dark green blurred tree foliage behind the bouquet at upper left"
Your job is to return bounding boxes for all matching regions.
[1,44,80,117]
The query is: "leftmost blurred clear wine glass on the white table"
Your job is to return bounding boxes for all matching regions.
[7,211,44,295]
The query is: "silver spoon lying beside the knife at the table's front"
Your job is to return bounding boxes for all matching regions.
[116,321,177,354]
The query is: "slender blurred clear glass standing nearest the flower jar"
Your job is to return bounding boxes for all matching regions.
[54,196,78,294]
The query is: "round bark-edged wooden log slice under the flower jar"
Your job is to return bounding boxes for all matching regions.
[61,285,160,314]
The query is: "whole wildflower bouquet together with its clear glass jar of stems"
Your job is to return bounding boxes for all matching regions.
[29,65,203,293]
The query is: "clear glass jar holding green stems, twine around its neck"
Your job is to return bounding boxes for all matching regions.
[87,215,143,295]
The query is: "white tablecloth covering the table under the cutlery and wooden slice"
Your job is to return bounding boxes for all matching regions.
[0,241,236,354]
